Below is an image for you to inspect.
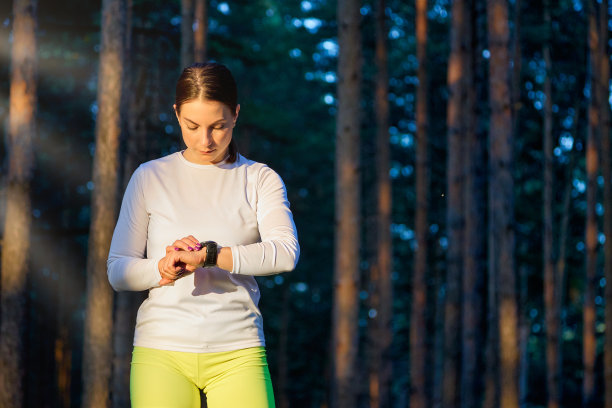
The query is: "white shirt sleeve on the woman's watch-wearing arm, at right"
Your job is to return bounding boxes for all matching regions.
[231,166,300,276]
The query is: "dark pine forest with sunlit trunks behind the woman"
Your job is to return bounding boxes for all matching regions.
[0,0,612,408]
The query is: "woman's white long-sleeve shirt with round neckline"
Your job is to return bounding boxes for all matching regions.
[108,152,300,353]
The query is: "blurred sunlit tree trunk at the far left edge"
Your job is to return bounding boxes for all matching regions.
[0,0,37,408]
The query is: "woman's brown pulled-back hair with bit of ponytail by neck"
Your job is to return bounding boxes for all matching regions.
[174,62,238,163]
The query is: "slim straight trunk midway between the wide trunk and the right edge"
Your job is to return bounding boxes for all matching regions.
[542,0,560,408]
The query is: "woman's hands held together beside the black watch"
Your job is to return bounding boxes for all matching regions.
[158,235,206,286]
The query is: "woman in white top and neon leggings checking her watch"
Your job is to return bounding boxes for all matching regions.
[108,63,299,408]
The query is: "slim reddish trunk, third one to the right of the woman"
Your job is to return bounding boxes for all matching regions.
[410,0,429,408]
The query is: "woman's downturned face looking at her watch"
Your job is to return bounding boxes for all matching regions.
[174,99,240,164]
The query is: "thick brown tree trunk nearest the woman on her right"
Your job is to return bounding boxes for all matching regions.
[332,0,361,408]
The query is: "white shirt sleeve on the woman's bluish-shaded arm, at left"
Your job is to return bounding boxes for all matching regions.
[107,166,161,291]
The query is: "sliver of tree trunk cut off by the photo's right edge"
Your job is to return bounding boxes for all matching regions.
[599,0,612,408]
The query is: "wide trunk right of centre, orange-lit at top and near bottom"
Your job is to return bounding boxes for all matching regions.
[487,0,518,408]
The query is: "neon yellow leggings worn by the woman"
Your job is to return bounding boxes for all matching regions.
[130,347,274,408]
